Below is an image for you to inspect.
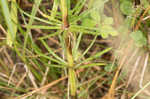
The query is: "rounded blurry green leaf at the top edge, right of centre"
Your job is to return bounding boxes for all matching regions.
[120,0,134,15]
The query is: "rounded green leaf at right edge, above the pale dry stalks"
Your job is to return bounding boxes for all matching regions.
[130,30,147,47]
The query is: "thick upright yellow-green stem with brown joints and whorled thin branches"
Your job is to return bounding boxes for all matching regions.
[61,0,76,97]
